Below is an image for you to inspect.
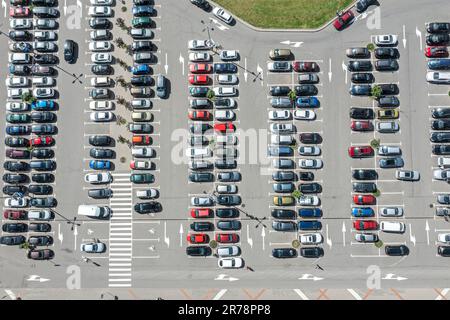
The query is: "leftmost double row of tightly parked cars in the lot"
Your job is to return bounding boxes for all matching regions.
[0,0,59,260]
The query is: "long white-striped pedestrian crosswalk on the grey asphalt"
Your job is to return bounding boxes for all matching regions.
[108,173,133,287]
